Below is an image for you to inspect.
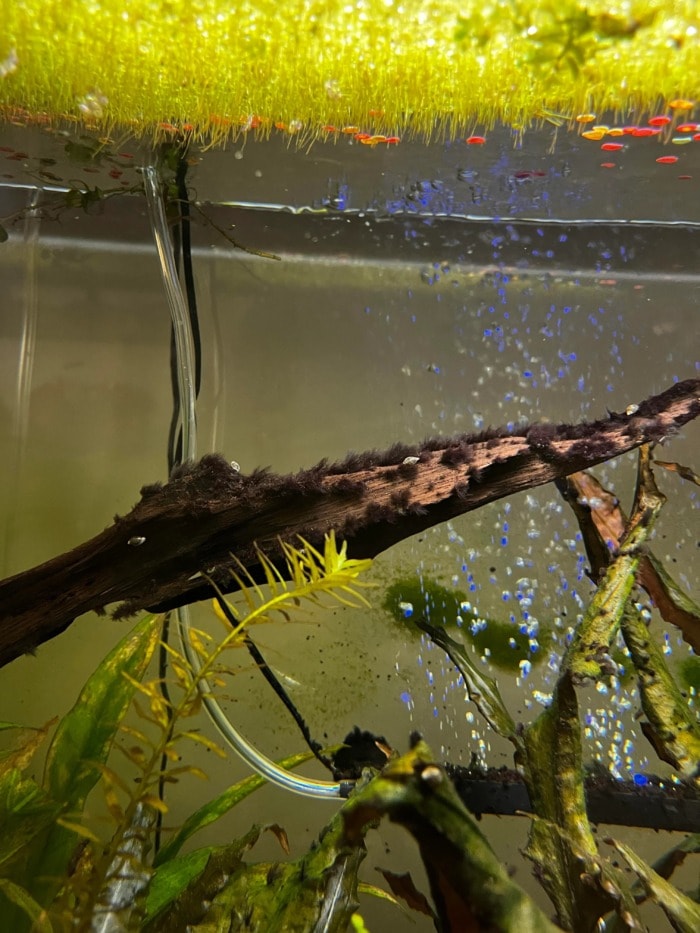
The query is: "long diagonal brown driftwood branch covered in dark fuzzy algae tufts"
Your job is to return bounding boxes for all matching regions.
[0,379,700,665]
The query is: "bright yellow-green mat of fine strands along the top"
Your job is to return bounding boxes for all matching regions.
[0,0,700,144]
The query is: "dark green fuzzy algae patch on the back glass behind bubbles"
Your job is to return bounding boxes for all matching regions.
[382,575,549,673]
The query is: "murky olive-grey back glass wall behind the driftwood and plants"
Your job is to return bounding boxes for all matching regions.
[0,123,700,930]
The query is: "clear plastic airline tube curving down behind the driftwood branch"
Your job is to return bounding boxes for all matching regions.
[144,165,348,800]
